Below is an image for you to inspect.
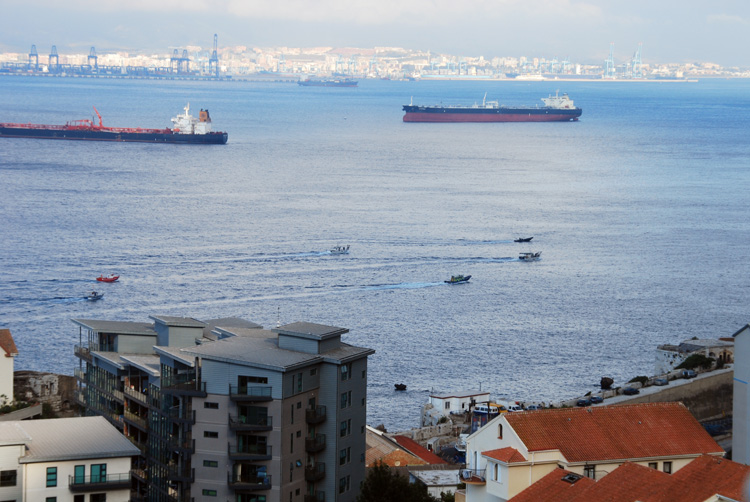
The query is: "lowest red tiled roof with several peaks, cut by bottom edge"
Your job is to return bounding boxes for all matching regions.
[510,455,750,502]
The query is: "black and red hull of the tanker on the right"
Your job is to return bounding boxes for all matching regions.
[404,105,581,122]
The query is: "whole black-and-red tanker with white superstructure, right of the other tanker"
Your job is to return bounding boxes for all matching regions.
[404,92,583,122]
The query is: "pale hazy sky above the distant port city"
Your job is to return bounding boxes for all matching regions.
[0,0,750,67]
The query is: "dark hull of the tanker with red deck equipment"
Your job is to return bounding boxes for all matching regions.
[0,127,229,145]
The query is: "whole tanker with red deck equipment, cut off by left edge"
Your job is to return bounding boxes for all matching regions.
[0,103,229,145]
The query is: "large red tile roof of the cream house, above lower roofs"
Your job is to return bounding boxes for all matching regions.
[503,403,724,462]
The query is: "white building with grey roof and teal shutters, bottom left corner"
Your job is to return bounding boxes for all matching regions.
[0,417,140,502]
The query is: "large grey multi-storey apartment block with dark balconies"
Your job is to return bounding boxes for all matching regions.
[73,316,374,502]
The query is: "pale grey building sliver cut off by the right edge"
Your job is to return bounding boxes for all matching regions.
[732,324,750,464]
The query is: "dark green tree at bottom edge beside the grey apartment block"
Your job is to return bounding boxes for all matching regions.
[357,462,440,502]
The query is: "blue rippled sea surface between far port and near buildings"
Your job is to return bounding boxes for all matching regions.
[0,77,750,430]
